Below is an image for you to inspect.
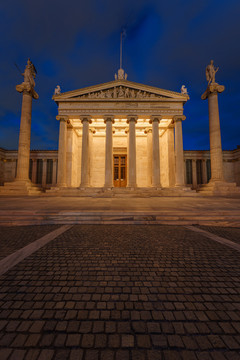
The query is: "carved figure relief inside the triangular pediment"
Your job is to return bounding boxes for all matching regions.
[77,85,166,99]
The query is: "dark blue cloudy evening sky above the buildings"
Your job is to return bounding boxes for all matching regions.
[0,0,240,149]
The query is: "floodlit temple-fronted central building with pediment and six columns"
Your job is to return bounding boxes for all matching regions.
[53,69,189,188]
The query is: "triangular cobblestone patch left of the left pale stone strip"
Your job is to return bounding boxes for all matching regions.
[0,225,60,260]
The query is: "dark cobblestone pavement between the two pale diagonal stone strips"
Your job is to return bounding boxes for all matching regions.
[0,225,240,360]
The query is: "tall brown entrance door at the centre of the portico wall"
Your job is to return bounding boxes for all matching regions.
[113,155,127,187]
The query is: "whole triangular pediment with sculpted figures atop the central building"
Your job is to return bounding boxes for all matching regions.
[53,80,188,102]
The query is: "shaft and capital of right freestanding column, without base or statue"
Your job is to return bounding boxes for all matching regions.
[201,82,225,182]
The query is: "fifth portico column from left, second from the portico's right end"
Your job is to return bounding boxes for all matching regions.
[150,115,161,187]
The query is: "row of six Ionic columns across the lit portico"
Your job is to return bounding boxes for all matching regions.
[57,115,185,188]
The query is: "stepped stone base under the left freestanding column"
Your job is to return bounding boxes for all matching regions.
[0,180,42,196]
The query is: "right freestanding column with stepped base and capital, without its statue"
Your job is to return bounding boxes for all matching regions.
[200,82,240,195]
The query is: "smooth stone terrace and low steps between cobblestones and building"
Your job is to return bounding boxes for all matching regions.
[0,194,240,227]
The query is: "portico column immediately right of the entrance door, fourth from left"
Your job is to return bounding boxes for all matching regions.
[127,115,138,188]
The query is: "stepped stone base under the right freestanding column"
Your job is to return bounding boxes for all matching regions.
[198,181,240,196]
